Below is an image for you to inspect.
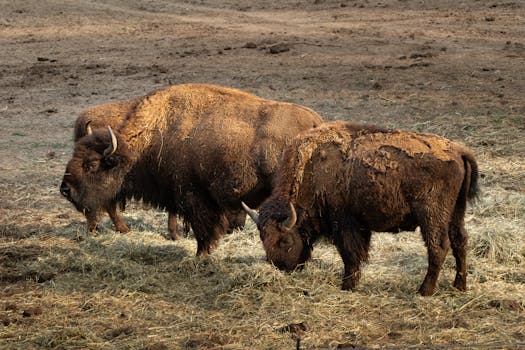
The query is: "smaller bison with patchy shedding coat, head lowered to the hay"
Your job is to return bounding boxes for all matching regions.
[243,122,478,295]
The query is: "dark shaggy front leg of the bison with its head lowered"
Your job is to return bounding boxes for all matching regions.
[332,218,372,290]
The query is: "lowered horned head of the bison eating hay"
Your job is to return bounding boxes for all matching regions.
[242,200,311,271]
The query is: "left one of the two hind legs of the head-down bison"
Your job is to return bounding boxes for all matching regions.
[419,225,450,296]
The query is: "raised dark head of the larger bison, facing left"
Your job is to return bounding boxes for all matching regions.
[60,126,131,230]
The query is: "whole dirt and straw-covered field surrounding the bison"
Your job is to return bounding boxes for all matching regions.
[0,0,525,350]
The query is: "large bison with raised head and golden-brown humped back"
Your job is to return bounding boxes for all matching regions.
[61,84,322,255]
